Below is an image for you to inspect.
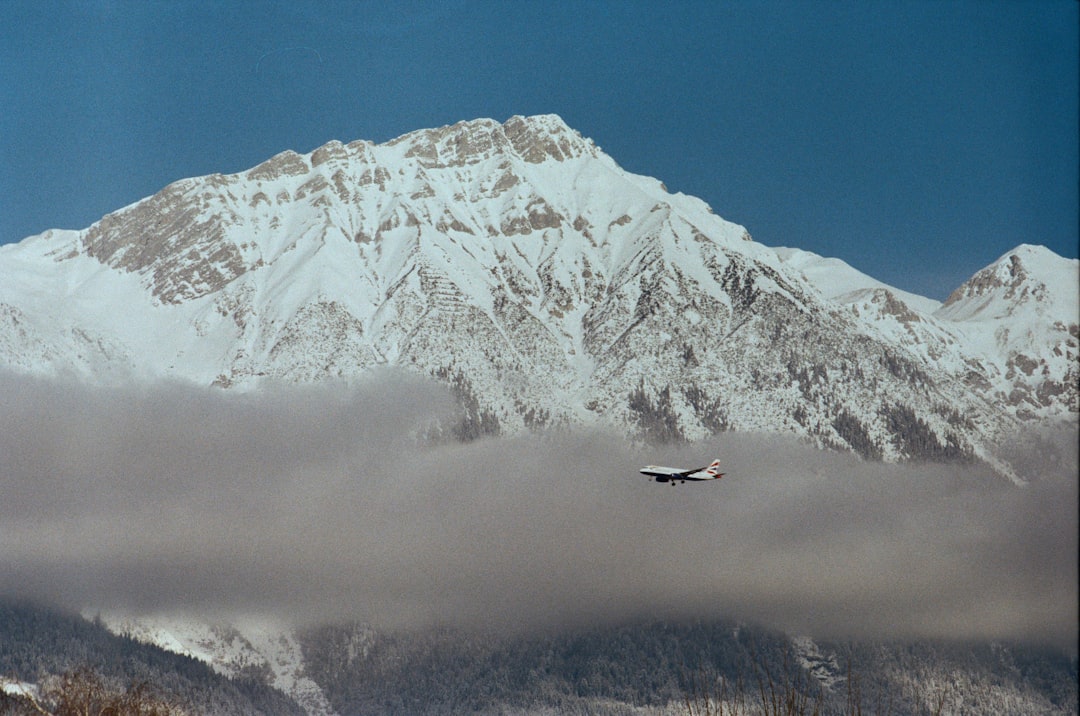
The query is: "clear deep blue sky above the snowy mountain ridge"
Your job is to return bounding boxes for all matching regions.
[0,0,1080,299]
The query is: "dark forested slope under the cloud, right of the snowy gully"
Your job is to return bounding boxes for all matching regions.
[303,621,1077,716]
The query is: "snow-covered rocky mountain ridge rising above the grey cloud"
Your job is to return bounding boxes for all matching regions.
[0,116,1080,481]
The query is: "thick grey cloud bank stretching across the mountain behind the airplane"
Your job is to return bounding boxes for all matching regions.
[0,374,1078,646]
